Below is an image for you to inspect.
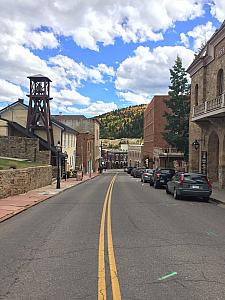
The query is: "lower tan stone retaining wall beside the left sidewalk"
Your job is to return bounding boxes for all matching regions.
[0,166,52,198]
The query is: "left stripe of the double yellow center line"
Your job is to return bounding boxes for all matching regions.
[98,177,114,300]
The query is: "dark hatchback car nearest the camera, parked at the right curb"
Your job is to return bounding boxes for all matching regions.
[166,173,212,201]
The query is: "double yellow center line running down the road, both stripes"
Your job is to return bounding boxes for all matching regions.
[98,175,121,300]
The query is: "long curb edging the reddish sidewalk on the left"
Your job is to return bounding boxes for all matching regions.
[0,174,100,223]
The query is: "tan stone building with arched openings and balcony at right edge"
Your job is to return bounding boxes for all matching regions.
[187,22,225,188]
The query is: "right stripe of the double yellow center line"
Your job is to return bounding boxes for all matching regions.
[107,176,121,300]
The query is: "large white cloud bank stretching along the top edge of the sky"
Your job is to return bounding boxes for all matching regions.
[0,0,205,50]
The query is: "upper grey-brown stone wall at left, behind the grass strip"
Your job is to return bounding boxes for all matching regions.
[0,136,51,164]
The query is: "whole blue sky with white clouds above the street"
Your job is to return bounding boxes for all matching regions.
[0,0,225,116]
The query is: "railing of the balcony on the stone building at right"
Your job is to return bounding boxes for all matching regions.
[192,94,225,119]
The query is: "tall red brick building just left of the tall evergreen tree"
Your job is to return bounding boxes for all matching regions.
[142,95,169,167]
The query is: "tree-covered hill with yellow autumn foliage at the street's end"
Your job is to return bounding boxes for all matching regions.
[97,104,147,139]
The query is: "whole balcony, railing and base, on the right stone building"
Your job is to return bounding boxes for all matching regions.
[192,94,225,121]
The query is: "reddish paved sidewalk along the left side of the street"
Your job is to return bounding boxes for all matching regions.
[0,173,99,222]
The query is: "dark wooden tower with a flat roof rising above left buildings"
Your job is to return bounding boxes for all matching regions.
[27,74,54,149]
